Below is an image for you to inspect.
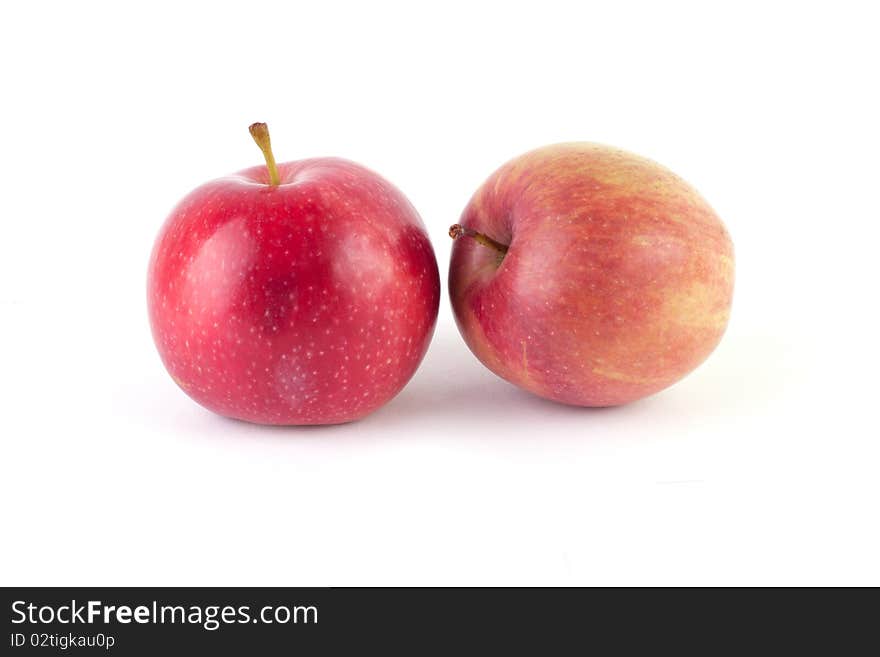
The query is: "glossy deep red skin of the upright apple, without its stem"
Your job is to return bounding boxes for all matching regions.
[147,158,440,425]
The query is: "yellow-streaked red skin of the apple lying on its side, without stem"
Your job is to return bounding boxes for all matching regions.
[449,143,734,406]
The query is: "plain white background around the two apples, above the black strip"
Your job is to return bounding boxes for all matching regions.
[0,0,880,585]
